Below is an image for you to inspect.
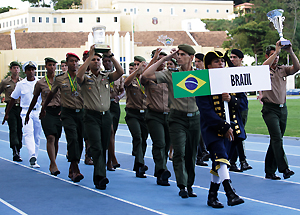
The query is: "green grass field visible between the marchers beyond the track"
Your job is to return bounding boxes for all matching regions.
[120,99,300,137]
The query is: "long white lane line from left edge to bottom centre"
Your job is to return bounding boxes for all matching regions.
[0,156,167,215]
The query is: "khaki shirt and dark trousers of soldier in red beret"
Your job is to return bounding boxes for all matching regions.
[51,72,83,162]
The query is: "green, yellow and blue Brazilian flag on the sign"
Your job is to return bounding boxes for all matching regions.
[172,69,211,98]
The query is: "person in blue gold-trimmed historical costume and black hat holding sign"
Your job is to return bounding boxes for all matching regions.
[196,51,246,208]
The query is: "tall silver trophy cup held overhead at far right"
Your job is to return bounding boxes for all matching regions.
[267,9,291,46]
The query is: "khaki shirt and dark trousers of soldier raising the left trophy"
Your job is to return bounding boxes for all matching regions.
[81,73,111,186]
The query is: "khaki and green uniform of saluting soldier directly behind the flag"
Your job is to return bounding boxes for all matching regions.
[155,68,200,191]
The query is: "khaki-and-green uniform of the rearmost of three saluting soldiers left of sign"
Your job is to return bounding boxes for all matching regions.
[125,78,148,172]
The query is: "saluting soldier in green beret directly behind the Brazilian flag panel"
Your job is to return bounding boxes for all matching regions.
[143,44,200,198]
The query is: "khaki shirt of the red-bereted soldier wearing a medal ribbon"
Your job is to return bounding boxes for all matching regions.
[51,72,83,109]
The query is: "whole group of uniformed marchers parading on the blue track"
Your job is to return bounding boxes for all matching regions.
[0,41,300,208]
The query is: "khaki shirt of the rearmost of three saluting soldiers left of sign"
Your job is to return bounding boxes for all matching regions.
[125,78,147,110]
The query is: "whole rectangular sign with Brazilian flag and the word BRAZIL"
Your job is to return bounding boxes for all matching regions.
[172,65,271,98]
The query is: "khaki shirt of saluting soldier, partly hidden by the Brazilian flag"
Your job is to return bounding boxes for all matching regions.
[155,68,198,113]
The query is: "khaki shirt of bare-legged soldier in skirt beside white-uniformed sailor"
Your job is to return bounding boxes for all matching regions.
[33,77,60,106]
